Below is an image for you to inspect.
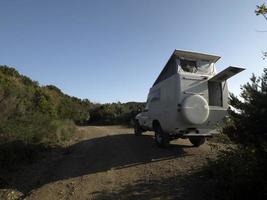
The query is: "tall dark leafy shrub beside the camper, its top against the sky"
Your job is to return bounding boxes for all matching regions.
[224,69,267,148]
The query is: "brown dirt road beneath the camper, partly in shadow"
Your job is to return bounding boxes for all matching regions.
[2,126,218,200]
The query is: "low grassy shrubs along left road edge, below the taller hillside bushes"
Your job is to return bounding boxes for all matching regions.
[0,119,76,169]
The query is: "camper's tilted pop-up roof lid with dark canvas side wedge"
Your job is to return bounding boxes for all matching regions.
[153,50,221,86]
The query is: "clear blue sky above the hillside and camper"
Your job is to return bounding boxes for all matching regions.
[0,0,267,103]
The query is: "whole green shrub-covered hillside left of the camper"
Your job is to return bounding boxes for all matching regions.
[0,66,144,166]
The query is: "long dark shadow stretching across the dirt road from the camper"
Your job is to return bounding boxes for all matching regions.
[0,133,191,194]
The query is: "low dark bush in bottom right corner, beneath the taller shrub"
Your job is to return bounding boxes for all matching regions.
[206,146,267,199]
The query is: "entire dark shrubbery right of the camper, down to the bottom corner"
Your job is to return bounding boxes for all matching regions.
[207,69,267,199]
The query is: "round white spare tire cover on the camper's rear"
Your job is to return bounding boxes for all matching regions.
[182,94,209,124]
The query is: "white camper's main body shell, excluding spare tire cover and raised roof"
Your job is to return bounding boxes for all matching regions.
[140,73,228,134]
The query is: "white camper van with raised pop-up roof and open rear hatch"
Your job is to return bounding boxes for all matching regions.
[135,50,244,147]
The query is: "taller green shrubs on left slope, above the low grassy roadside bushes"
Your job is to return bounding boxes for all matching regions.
[0,66,92,123]
